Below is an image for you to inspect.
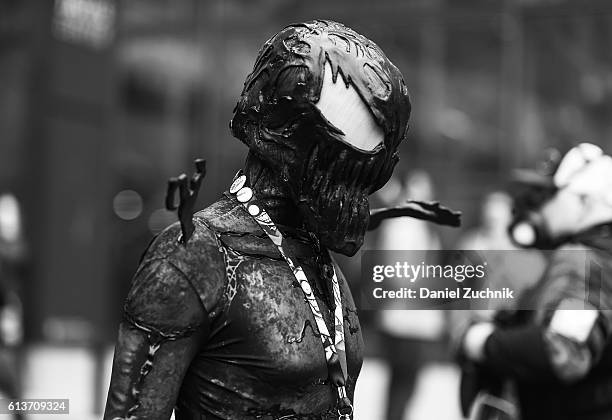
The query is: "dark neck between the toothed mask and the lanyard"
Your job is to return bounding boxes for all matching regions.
[244,152,304,228]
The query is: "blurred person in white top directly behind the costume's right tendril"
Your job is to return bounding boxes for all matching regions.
[377,170,445,420]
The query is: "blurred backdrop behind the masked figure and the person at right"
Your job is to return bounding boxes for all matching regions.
[0,0,612,420]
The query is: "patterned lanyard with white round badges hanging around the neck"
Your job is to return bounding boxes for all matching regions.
[229,172,353,420]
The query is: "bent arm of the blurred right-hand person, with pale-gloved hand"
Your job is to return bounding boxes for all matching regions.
[463,252,612,383]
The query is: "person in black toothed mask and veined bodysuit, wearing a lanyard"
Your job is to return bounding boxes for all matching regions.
[104,21,410,420]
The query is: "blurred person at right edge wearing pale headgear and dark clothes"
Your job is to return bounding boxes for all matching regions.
[461,144,612,420]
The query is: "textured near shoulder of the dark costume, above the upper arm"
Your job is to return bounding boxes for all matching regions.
[125,199,241,333]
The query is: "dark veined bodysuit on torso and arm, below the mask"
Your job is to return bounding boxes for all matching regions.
[105,197,363,420]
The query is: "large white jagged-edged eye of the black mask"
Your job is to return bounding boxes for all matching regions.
[316,61,385,152]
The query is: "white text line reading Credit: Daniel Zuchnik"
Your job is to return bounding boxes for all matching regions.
[372,287,514,299]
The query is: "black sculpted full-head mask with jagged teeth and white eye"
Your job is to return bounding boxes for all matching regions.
[231,20,410,255]
